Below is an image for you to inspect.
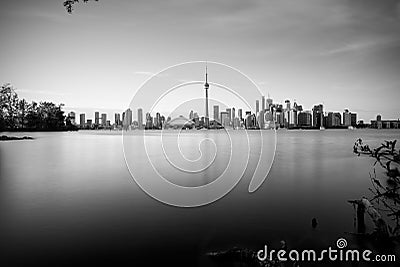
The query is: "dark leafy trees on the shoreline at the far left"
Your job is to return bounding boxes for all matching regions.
[0,83,76,131]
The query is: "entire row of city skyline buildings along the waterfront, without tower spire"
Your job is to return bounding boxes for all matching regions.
[67,99,400,130]
